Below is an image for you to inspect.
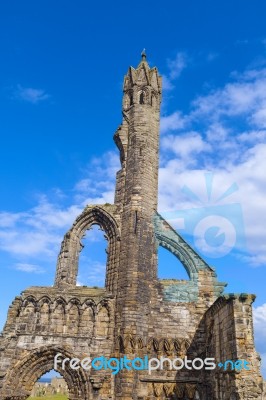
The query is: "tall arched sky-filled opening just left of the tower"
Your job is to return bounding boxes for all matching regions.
[77,225,108,287]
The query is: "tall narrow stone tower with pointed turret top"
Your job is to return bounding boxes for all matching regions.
[115,52,161,336]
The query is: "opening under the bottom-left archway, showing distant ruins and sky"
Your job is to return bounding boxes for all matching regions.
[28,370,69,400]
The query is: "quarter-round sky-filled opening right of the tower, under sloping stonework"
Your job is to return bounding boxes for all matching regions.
[158,246,190,281]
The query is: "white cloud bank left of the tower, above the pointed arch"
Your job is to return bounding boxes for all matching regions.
[0,152,117,265]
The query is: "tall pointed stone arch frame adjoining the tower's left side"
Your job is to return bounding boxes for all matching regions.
[55,205,120,291]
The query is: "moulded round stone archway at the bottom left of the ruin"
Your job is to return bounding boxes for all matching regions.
[2,347,90,400]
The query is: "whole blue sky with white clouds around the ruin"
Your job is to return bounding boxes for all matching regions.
[0,0,266,380]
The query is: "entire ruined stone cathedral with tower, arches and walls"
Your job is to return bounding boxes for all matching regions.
[0,52,262,400]
